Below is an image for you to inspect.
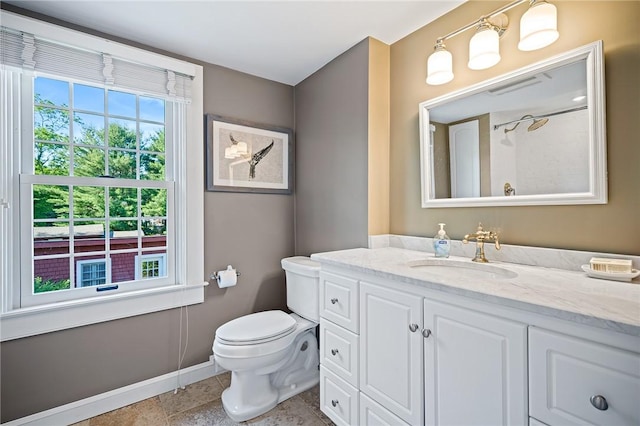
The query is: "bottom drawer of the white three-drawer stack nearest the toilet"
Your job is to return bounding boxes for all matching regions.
[320,366,358,426]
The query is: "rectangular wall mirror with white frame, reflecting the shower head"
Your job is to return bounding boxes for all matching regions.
[420,41,607,208]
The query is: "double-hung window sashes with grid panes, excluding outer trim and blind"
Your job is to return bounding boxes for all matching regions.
[20,77,175,306]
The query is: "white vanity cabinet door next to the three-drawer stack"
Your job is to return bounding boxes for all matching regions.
[360,282,424,425]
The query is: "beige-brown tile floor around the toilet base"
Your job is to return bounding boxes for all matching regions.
[73,373,333,426]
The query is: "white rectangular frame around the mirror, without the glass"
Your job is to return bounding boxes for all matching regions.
[419,40,607,208]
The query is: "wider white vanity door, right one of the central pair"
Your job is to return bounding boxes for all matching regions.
[424,300,529,426]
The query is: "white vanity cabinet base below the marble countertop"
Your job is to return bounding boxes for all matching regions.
[320,265,640,426]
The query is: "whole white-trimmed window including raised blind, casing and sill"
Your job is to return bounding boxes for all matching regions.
[0,11,206,341]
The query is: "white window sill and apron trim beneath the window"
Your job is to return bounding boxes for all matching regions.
[0,282,208,342]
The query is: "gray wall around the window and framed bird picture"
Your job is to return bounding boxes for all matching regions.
[0,5,294,422]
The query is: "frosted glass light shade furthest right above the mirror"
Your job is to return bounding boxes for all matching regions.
[518,1,560,51]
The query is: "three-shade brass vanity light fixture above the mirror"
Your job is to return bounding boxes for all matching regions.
[427,0,559,85]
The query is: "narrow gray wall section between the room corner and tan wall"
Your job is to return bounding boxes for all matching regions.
[295,39,369,255]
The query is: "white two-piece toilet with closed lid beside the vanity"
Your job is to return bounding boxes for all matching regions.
[213,256,320,422]
